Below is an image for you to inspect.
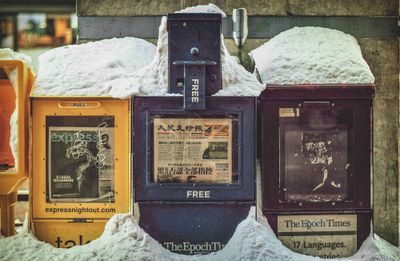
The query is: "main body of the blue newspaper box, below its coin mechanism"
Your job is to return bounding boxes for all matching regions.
[133,97,256,254]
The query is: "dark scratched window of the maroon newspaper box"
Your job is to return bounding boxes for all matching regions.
[279,108,353,202]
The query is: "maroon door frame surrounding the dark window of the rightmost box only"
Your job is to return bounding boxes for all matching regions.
[259,85,373,212]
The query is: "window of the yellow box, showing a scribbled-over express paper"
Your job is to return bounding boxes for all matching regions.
[46,116,115,202]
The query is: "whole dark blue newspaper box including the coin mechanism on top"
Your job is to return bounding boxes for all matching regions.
[133,14,256,254]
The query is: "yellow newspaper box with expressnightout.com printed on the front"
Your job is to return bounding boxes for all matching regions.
[31,97,131,247]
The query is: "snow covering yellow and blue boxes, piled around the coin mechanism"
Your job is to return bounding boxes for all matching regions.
[34,4,263,99]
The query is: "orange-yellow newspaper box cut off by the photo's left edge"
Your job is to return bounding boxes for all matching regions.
[0,60,35,236]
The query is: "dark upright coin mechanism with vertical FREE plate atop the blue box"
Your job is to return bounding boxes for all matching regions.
[168,13,222,110]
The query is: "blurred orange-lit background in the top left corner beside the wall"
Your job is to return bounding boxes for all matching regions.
[0,0,77,70]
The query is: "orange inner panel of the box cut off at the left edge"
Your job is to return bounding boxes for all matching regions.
[0,79,16,169]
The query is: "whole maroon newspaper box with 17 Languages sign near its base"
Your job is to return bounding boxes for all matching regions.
[259,85,374,258]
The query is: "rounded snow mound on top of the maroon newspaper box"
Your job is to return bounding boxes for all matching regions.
[250,27,375,84]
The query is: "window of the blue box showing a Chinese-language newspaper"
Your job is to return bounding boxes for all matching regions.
[152,116,238,184]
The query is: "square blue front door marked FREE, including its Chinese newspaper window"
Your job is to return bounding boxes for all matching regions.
[133,97,255,201]
